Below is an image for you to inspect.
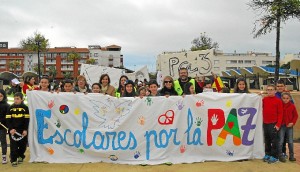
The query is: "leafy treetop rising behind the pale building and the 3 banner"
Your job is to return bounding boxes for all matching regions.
[191,32,219,51]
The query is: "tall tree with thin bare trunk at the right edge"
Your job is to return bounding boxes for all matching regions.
[248,0,300,81]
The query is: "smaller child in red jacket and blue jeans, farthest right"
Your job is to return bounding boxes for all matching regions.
[279,92,298,161]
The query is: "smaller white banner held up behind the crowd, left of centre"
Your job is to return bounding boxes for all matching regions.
[80,64,125,88]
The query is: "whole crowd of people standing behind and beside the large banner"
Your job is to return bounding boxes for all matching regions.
[0,68,298,167]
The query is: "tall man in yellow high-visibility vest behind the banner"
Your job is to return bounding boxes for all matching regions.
[174,68,203,96]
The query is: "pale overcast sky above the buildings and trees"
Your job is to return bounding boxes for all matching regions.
[0,0,300,71]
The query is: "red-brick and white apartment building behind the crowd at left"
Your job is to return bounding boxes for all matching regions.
[0,42,123,79]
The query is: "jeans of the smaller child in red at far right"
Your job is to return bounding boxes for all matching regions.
[279,125,294,156]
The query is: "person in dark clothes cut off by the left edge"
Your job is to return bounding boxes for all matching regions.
[0,89,9,164]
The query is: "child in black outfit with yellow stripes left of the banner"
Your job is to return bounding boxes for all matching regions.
[6,92,29,167]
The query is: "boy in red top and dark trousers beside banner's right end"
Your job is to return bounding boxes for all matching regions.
[263,85,285,163]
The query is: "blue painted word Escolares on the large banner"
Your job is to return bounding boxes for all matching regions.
[36,109,137,150]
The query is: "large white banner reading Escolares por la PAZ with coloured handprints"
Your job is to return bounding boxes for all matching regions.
[27,91,264,164]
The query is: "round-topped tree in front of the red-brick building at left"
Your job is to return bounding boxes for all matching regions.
[20,31,50,79]
